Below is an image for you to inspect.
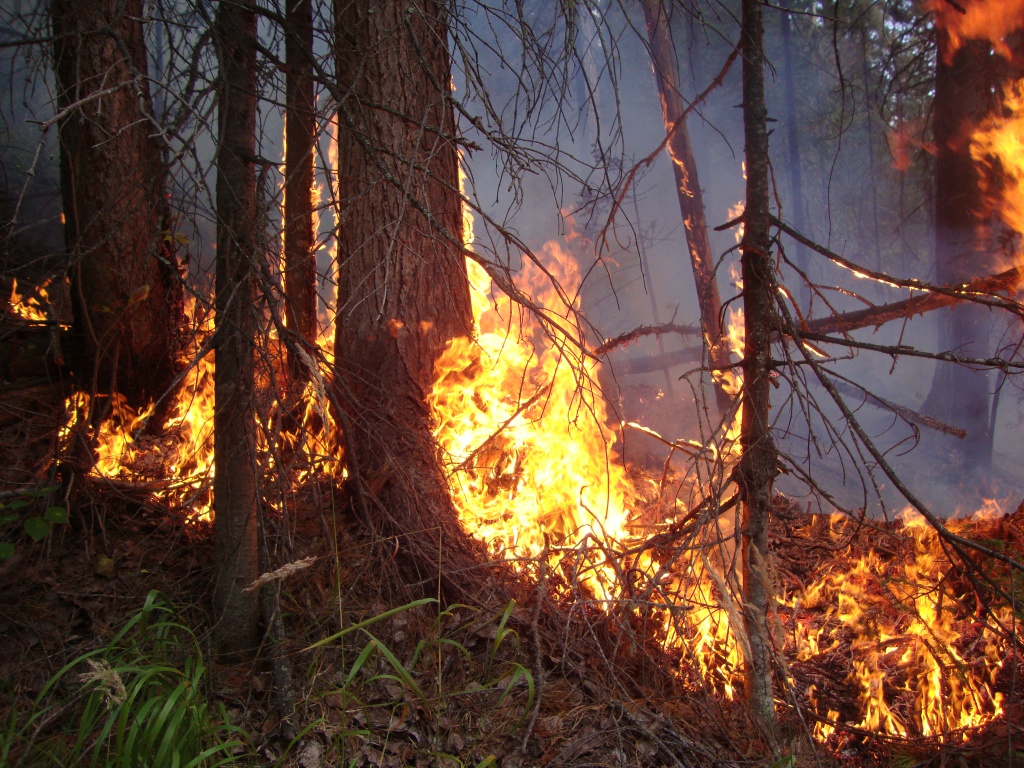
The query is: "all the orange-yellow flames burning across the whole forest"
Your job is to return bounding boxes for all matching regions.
[25,19,1024,757]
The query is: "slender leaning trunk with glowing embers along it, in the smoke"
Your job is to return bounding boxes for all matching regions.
[641,0,732,413]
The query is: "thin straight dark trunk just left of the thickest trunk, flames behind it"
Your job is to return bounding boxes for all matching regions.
[284,0,316,395]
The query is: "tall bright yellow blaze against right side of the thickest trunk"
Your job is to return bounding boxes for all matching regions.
[428,169,631,591]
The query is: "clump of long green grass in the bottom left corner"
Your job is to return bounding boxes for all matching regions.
[0,592,245,768]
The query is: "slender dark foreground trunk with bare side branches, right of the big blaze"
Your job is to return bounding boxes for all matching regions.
[736,0,777,735]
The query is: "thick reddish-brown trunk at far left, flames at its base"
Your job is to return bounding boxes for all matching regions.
[50,0,183,409]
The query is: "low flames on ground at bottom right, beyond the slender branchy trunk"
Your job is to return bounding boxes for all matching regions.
[782,510,1011,738]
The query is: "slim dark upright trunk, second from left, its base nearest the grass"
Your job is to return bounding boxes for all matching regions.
[213,2,259,655]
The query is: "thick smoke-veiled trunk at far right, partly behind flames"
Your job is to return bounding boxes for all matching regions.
[921,36,1001,481]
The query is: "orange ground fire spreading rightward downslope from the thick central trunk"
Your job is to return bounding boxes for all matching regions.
[430,173,1012,739]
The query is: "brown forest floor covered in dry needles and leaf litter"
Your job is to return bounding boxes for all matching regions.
[0,370,1024,768]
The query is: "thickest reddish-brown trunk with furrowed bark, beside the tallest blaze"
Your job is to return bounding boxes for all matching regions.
[335,0,487,599]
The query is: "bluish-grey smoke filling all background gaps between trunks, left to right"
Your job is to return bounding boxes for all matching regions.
[0,3,1024,515]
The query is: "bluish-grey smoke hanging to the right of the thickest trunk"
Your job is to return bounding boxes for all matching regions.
[457,5,1022,516]
